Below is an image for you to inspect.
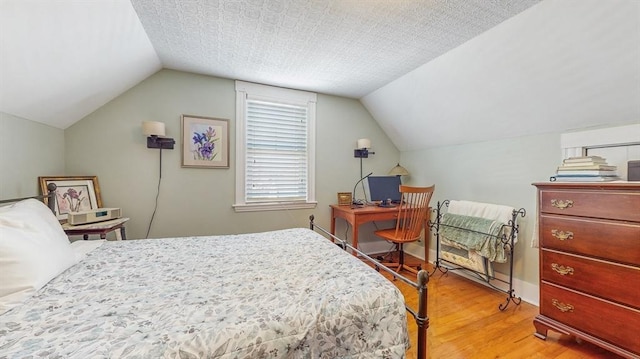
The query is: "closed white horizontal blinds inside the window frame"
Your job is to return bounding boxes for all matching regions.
[245,99,308,203]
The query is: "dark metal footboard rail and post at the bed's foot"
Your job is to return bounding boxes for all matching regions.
[309,215,429,359]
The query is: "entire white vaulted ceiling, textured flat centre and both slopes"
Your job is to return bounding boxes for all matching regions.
[0,0,640,150]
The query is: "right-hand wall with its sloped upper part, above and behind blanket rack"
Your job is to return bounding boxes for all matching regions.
[362,0,640,302]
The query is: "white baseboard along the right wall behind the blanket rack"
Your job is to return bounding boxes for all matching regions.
[404,243,540,306]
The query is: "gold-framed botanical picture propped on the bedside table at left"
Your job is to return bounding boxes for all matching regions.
[38,176,102,220]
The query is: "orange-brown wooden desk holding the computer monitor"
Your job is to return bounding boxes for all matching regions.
[330,204,431,260]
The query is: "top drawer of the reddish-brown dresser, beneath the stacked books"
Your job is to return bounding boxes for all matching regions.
[540,189,640,222]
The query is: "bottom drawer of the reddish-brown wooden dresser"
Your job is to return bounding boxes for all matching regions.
[540,282,640,354]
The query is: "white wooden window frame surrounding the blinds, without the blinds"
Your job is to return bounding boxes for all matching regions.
[233,81,318,212]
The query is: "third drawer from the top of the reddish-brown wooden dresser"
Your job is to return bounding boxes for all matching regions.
[540,249,640,309]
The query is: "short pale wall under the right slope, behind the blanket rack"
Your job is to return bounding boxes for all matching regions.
[401,134,561,283]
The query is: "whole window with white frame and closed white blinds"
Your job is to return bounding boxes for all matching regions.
[234,81,316,212]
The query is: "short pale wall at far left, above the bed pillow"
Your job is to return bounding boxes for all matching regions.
[0,112,65,199]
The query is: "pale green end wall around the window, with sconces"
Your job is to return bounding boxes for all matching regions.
[65,70,399,242]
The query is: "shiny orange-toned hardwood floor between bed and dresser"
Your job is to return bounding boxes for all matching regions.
[368,257,621,359]
